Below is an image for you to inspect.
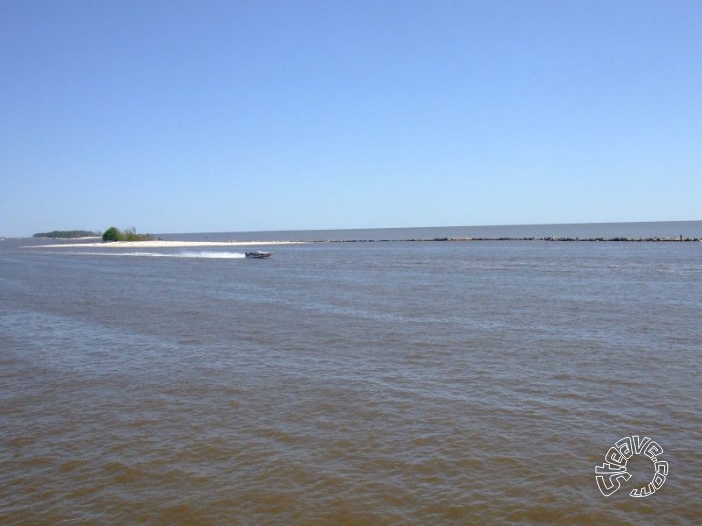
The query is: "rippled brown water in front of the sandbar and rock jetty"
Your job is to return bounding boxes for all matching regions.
[0,226,702,525]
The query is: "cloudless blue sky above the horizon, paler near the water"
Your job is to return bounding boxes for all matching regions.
[0,0,702,236]
